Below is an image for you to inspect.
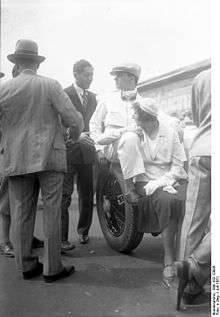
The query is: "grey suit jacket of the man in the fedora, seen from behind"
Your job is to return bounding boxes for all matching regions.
[0,70,83,176]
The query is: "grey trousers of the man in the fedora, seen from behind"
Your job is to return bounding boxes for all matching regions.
[9,171,63,275]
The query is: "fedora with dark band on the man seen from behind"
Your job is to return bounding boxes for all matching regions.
[7,39,45,64]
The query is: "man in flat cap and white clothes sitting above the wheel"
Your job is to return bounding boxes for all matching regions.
[90,63,142,203]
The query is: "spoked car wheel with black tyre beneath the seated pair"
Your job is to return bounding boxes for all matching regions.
[96,165,143,254]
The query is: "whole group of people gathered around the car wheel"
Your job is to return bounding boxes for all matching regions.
[0,40,211,309]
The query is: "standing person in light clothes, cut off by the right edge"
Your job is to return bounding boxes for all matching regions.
[176,70,211,309]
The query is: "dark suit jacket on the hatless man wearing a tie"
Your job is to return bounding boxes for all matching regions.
[64,85,97,164]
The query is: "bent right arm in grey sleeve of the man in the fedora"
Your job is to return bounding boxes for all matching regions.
[51,81,84,133]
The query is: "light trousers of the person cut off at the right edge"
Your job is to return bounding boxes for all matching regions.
[179,156,211,286]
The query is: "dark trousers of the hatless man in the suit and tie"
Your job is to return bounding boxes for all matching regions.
[61,164,93,241]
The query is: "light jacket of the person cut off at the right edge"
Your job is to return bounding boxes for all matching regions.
[190,69,211,157]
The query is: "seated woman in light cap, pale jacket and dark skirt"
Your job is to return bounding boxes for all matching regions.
[131,98,187,284]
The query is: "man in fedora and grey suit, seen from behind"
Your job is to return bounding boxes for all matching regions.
[0,39,83,282]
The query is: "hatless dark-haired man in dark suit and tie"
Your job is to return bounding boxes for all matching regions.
[62,60,97,247]
